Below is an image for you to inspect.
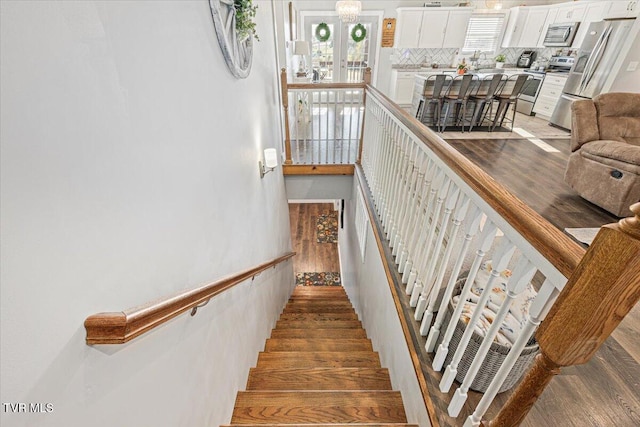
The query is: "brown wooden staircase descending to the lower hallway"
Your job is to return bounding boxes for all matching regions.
[224,286,416,427]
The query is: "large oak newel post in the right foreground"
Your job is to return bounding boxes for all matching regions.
[482,203,640,427]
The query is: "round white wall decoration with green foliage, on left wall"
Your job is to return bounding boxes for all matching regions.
[209,0,258,79]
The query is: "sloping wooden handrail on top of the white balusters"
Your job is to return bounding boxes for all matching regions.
[365,85,585,277]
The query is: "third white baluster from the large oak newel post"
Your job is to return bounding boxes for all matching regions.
[440,237,516,393]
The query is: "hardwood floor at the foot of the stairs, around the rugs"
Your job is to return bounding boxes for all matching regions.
[289,203,340,273]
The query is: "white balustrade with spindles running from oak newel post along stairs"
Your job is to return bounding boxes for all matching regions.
[362,89,579,426]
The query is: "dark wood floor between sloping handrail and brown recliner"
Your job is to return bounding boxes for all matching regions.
[447,138,618,230]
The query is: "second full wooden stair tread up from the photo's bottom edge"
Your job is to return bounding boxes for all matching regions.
[247,368,391,390]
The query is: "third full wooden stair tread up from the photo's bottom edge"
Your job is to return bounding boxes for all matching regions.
[256,351,380,368]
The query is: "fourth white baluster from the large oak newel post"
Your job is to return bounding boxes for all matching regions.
[433,221,497,372]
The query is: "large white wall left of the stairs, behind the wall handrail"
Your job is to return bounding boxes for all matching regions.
[0,0,293,427]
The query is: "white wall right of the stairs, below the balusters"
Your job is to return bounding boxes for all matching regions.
[338,178,431,427]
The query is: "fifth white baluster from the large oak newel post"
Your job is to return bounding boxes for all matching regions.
[420,205,482,344]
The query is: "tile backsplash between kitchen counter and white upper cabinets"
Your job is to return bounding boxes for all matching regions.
[391,48,558,66]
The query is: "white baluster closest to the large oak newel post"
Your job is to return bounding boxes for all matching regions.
[464,280,561,427]
